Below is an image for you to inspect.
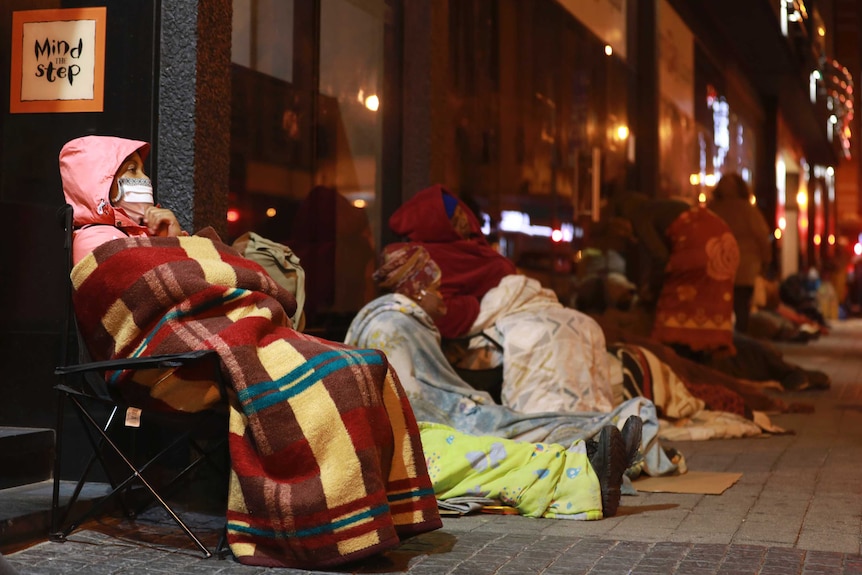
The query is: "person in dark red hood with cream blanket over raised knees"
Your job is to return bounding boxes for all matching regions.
[389,185,613,413]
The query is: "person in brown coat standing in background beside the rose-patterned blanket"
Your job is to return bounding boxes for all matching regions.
[707,173,772,333]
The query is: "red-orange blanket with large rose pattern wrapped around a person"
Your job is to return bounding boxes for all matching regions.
[652,207,739,354]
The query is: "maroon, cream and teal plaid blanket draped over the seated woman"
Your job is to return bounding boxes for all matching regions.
[72,232,441,568]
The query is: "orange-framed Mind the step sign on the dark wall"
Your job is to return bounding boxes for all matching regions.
[9,7,107,114]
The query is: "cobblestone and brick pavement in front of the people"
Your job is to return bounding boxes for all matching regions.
[5,320,862,575]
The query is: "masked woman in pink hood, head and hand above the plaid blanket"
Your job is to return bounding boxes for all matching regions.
[60,136,188,263]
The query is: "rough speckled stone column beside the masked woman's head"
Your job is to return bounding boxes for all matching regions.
[159,0,233,234]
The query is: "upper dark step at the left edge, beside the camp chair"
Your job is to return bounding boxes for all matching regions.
[0,427,55,489]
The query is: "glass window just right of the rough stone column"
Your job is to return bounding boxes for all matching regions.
[227,0,386,337]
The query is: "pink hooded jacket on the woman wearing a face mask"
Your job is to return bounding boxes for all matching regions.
[60,136,150,264]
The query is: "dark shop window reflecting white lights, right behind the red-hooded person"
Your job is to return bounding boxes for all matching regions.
[446,0,634,301]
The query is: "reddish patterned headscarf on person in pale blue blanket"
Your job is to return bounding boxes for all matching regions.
[372,244,440,301]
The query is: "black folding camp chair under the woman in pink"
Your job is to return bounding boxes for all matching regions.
[50,205,228,557]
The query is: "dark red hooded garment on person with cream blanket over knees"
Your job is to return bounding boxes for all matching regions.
[389,184,517,338]
